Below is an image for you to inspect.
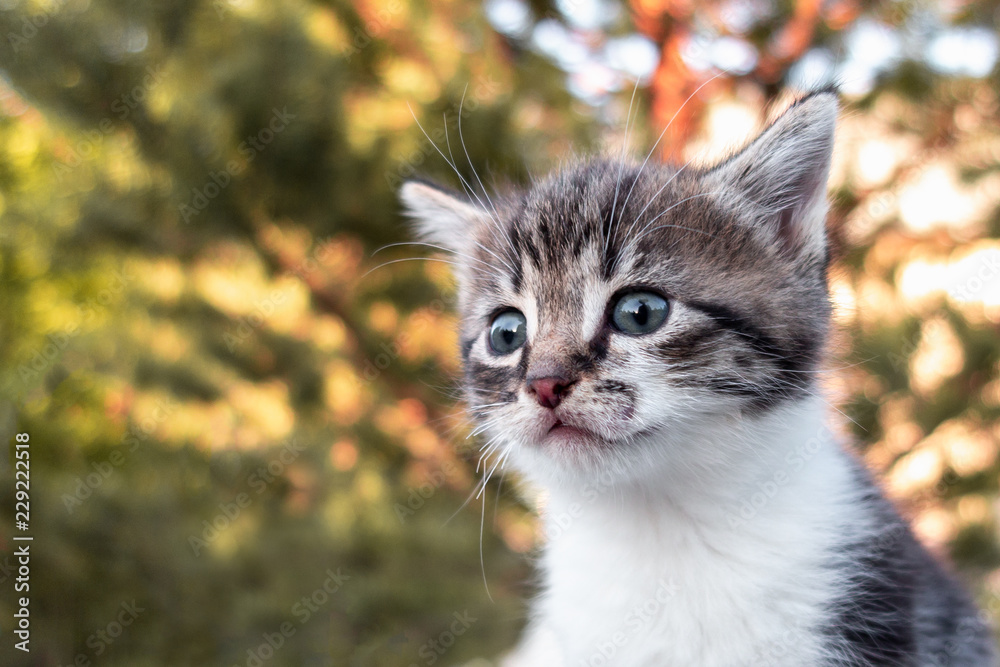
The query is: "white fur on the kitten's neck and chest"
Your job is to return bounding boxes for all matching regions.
[503,399,865,667]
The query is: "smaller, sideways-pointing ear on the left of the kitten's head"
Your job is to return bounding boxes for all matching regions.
[399,181,485,252]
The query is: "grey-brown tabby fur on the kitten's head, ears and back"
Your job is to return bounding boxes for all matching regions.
[402,91,996,667]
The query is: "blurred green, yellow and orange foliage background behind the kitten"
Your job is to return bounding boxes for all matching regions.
[0,0,1000,667]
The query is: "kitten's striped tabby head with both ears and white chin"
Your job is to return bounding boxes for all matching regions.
[401,92,837,486]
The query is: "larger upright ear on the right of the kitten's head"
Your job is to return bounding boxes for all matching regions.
[712,90,837,256]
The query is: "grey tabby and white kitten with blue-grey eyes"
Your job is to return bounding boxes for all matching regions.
[401,91,996,667]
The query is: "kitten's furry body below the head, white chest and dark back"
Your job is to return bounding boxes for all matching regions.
[504,400,994,667]
